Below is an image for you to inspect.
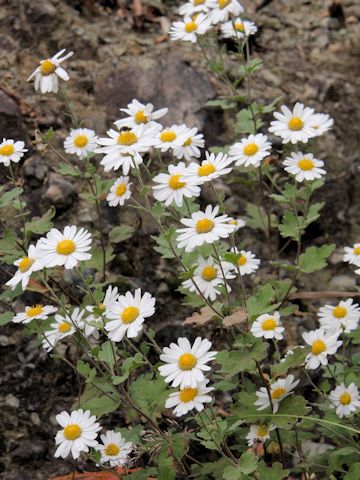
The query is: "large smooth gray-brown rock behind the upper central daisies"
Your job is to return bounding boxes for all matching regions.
[95,50,215,130]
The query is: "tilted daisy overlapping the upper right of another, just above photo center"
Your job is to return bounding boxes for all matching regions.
[186,152,232,184]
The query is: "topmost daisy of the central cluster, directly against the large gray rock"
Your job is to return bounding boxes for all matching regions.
[114,99,168,130]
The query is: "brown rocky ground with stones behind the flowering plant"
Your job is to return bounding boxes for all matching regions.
[0,0,360,480]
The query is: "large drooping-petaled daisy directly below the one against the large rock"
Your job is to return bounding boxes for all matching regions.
[95,125,157,175]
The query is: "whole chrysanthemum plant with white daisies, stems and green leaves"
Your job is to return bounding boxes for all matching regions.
[0,0,360,480]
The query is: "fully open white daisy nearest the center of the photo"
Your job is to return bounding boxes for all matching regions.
[176,205,235,252]
